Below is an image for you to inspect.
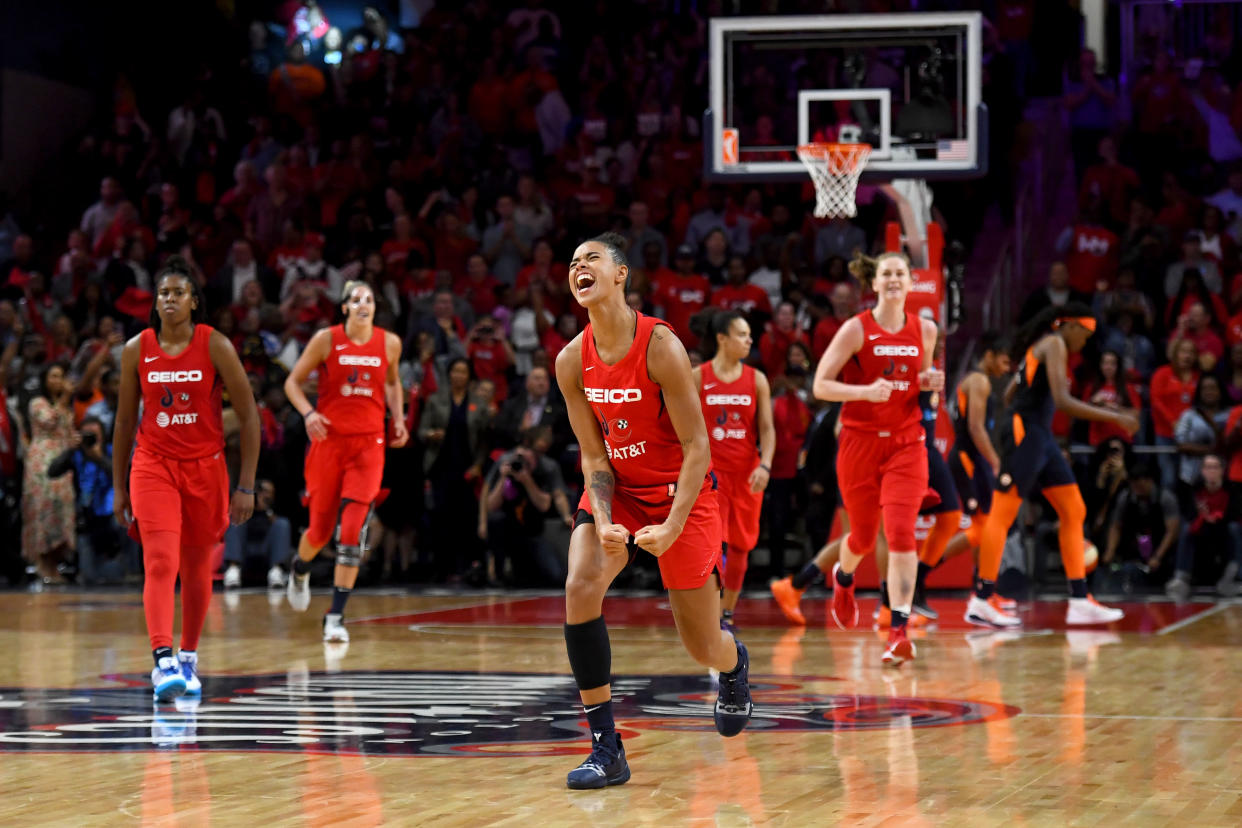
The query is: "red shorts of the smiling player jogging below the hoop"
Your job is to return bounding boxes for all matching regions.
[837,426,928,555]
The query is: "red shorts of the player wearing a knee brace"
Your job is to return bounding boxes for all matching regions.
[306,433,384,546]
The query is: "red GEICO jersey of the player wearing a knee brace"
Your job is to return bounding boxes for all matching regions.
[315,325,388,434]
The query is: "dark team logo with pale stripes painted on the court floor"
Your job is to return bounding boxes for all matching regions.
[0,672,1017,756]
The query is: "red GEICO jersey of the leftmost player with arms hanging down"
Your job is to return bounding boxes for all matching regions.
[138,323,225,461]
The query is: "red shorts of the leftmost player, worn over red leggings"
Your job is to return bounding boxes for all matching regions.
[129,447,229,549]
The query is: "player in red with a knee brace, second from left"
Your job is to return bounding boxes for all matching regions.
[284,282,409,644]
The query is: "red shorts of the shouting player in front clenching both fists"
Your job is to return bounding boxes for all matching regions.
[578,475,720,590]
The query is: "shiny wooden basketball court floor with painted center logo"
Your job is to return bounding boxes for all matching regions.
[0,592,1242,826]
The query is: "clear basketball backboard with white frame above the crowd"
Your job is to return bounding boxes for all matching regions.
[703,11,987,181]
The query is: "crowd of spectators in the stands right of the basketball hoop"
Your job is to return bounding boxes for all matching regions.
[1020,38,1242,598]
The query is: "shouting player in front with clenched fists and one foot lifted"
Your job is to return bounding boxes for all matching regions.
[556,233,751,790]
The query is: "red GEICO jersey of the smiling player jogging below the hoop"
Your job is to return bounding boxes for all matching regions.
[841,310,923,434]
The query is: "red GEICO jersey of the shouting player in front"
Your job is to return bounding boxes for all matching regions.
[582,313,705,489]
